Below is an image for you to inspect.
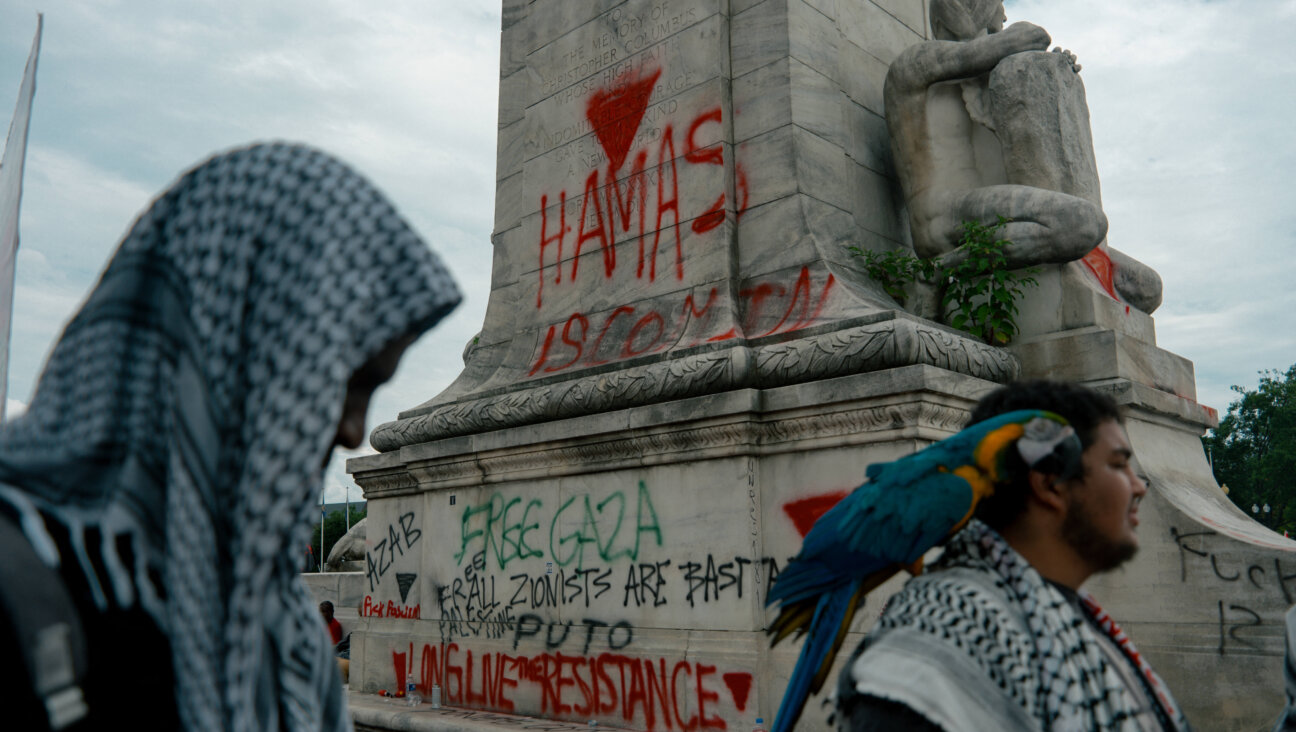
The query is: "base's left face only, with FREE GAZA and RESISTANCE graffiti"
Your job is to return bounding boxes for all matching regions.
[350,365,994,729]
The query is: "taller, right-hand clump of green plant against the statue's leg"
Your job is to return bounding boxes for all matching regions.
[941,216,1039,346]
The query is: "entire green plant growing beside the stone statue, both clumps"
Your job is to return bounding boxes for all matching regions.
[848,216,1039,346]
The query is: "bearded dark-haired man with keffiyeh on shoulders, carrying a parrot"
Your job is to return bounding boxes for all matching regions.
[836,381,1190,732]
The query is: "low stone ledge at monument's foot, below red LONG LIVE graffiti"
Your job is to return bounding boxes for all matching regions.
[347,692,616,732]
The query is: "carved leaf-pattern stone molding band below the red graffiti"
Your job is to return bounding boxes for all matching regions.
[371,317,1019,452]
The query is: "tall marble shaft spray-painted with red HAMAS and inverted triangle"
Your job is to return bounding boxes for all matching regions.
[375,0,1015,450]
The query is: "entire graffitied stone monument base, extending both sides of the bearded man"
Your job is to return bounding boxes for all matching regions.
[339,349,1296,731]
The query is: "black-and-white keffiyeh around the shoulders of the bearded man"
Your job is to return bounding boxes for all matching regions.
[839,520,1188,732]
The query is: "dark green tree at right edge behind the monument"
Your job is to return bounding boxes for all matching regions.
[1201,365,1296,534]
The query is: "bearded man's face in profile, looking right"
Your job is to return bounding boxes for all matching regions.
[1061,420,1147,571]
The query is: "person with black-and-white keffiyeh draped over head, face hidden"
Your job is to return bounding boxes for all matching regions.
[0,144,460,731]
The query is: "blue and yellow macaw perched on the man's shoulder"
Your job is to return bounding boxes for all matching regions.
[766,409,1081,732]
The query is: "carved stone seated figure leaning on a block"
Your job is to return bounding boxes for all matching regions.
[885,0,1161,312]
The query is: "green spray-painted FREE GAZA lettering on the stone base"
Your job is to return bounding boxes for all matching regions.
[455,481,662,569]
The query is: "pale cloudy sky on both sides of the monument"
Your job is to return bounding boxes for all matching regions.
[0,0,1296,500]
